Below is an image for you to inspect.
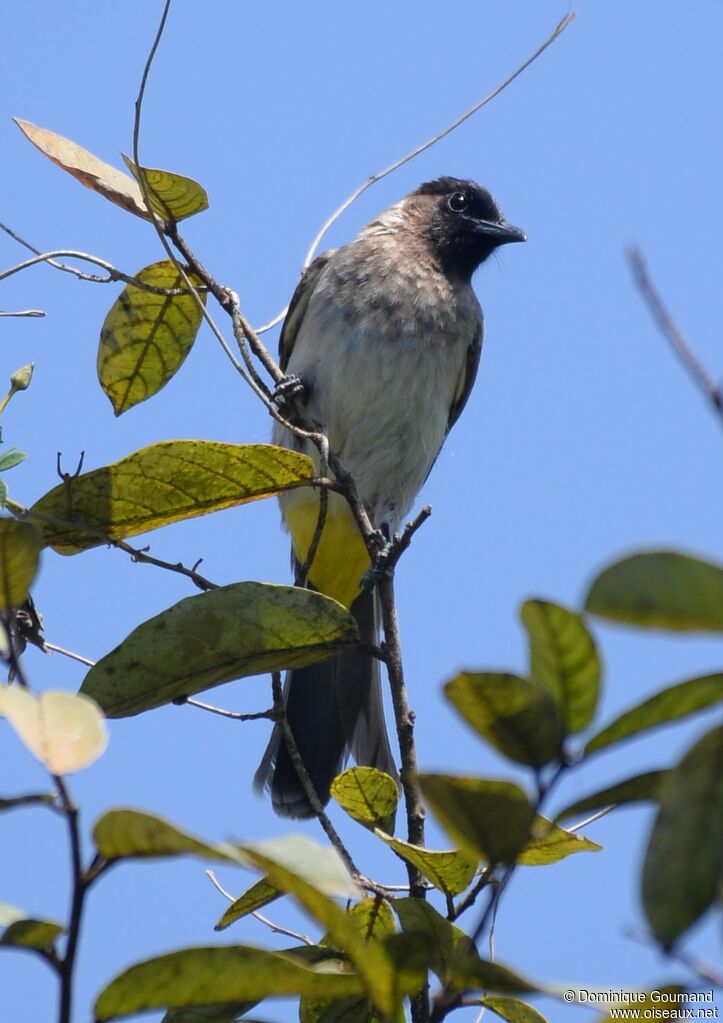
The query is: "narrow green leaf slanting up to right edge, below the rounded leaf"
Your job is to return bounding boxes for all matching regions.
[585,674,723,754]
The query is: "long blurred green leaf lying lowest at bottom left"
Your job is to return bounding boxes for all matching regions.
[95,945,362,1020]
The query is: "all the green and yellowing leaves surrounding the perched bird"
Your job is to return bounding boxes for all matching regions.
[0,19,723,1023]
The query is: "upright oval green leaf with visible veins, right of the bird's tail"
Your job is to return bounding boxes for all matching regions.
[521,601,601,732]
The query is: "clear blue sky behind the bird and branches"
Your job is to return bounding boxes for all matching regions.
[0,0,723,1023]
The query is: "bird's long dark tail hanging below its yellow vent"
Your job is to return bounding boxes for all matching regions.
[254,592,398,817]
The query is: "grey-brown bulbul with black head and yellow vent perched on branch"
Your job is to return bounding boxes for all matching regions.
[255,177,526,817]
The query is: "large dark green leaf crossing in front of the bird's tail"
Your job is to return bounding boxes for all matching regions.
[81,582,356,717]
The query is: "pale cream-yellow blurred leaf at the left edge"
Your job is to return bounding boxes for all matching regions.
[0,685,107,774]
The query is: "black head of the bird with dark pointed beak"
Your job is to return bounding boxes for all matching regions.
[412,177,527,277]
